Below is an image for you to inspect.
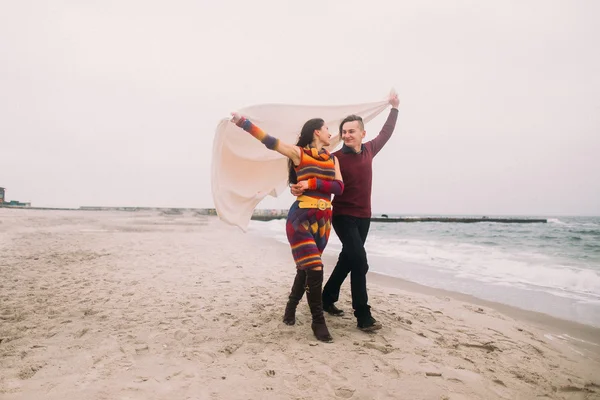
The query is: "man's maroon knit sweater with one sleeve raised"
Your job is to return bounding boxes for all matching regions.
[332,108,398,218]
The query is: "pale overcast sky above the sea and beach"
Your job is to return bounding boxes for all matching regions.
[0,0,600,215]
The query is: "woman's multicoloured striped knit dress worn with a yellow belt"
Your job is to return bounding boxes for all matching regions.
[286,148,343,269]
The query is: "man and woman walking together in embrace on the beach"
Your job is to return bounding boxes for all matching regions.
[232,93,400,342]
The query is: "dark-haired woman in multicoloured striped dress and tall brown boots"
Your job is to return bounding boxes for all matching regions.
[232,113,344,342]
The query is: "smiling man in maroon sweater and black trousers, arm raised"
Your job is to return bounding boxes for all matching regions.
[291,93,400,331]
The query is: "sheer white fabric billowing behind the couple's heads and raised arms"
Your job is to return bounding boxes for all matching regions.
[212,100,388,231]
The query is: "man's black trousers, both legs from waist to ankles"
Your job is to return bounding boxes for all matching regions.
[323,215,371,320]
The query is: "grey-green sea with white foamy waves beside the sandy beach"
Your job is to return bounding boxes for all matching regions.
[249,214,600,327]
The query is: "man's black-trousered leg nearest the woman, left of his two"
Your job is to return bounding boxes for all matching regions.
[323,215,361,315]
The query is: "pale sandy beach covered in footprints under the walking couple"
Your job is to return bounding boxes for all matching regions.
[0,209,600,400]
